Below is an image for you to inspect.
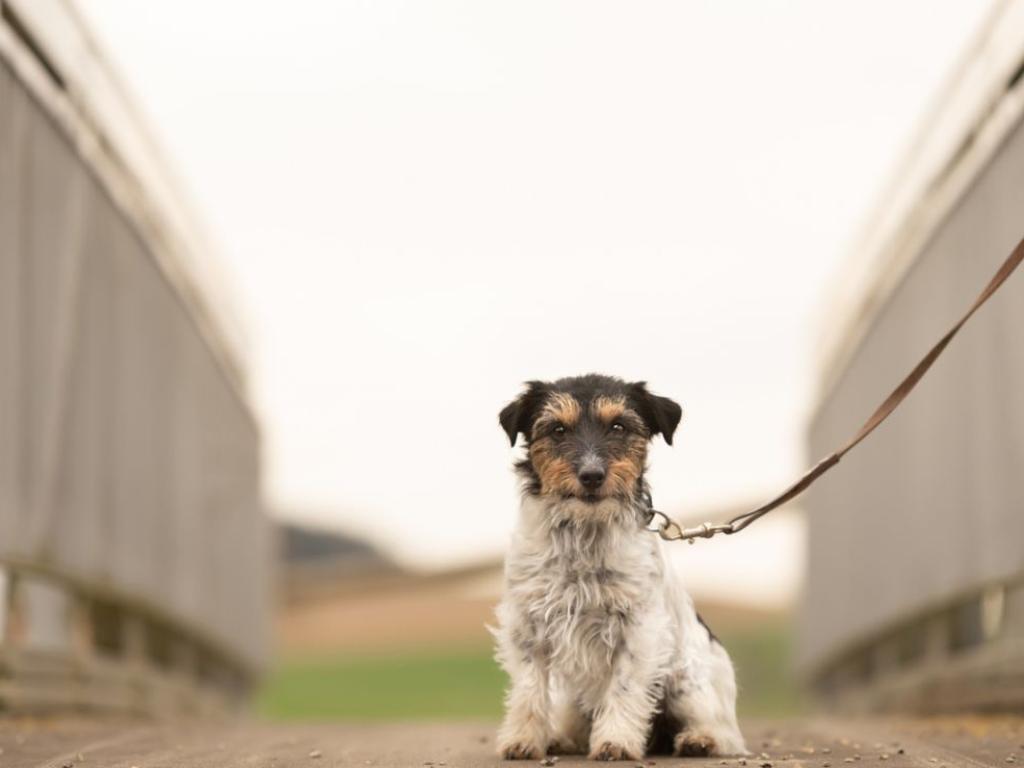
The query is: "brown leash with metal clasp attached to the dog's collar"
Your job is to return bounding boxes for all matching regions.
[644,240,1024,544]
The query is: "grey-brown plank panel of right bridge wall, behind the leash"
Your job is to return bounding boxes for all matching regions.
[799,91,1024,674]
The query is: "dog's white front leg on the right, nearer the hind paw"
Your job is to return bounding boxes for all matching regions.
[590,643,655,760]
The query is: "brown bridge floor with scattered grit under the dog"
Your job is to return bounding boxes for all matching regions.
[0,718,1024,768]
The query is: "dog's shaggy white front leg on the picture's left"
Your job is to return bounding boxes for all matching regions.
[498,627,551,760]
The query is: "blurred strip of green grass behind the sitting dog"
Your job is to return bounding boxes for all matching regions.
[257,623,800,720]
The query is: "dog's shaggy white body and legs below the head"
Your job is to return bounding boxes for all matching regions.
[495,494,745,759]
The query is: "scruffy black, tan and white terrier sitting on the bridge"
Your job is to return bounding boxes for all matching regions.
[494,374,746,760]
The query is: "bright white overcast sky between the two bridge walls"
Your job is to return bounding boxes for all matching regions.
[79,0,988,564]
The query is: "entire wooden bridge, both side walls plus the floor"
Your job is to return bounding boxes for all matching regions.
[0,0,1024,768]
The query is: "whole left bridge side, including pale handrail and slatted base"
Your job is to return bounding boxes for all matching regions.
[0,1,271,716]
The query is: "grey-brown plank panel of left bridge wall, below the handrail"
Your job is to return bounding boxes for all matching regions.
[0,48,270,676]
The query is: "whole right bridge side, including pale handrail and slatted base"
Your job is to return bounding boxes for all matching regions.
[800,3,1024,712]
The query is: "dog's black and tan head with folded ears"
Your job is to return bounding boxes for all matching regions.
[498,374,683,503]
